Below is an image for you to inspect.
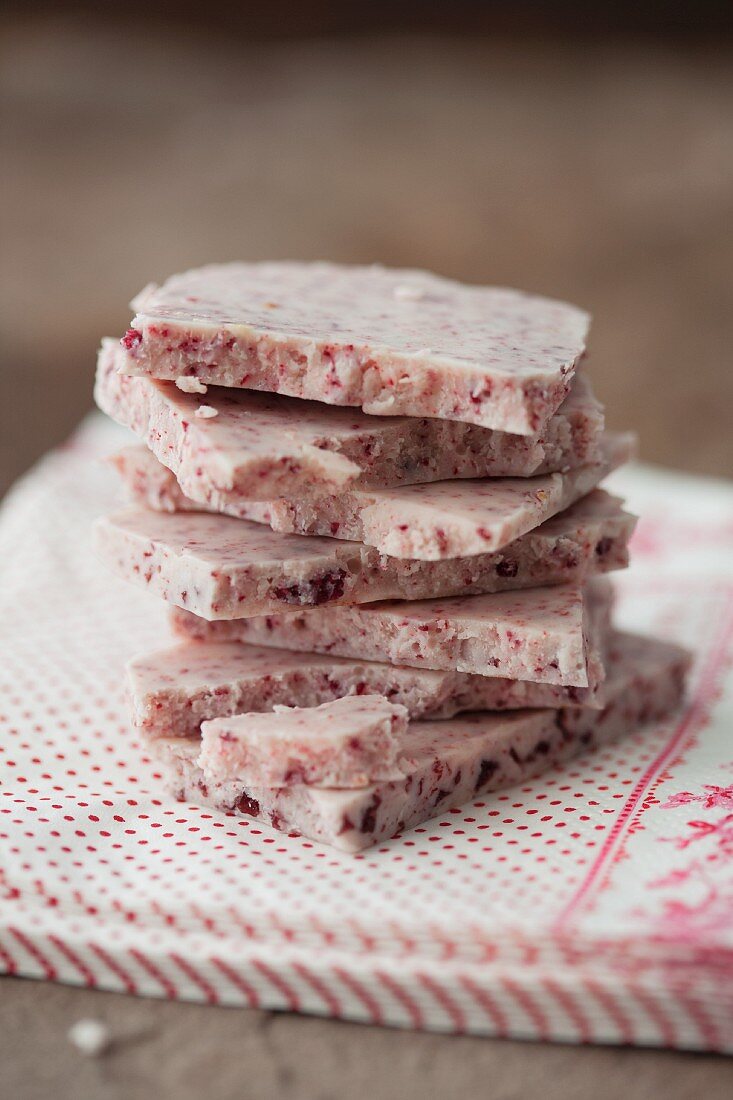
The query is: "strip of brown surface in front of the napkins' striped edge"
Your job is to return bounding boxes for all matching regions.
[0,979,733,1100]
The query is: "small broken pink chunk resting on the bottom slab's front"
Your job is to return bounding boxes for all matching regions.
[198,695,409,789]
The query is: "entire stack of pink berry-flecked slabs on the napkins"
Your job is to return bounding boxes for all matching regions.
[89,263,688,851]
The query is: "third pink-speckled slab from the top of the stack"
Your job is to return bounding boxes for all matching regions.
[108,436,633,561]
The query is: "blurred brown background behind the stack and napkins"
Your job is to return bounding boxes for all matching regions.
[0,0,733,491]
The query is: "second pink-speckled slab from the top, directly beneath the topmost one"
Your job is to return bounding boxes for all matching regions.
[95,340,603,499]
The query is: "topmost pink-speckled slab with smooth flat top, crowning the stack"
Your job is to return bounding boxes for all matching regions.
[122,263,589,436]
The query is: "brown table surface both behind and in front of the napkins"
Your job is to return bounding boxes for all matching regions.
[0,18,733,1100]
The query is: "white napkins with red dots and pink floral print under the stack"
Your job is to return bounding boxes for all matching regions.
[0,417,733,1051]
